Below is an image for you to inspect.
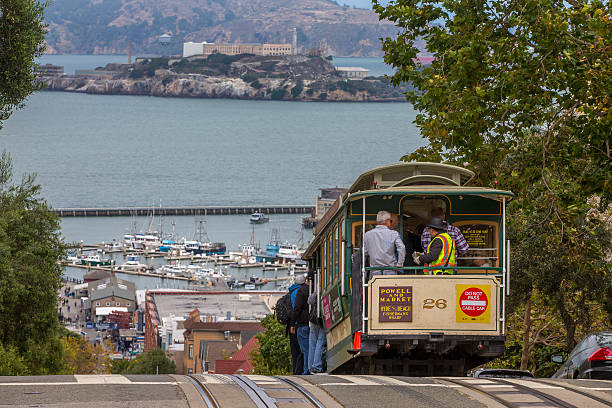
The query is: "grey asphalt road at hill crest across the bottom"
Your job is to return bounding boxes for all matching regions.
[0,375,612,408]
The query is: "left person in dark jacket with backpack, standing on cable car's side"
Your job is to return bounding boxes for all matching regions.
[289,275,310,375]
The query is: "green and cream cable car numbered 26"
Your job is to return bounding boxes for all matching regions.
[302,163,513,376]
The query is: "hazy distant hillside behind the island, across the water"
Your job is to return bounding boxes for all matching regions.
[46,0,396,56]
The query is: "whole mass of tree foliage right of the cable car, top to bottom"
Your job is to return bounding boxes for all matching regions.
[374,0,612,362]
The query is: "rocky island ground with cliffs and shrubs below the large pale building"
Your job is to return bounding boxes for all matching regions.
[38,53,407,102]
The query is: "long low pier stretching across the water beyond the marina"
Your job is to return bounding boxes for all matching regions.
[54,205,314,217]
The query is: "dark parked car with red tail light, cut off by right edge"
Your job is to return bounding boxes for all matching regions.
[552,331,612,380]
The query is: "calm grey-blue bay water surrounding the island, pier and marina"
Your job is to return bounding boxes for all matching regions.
[0,55,422,287]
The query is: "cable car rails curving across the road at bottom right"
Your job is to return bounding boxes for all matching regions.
[442,378,610,408]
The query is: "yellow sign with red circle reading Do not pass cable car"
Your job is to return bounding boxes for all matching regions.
[456,285,491,323]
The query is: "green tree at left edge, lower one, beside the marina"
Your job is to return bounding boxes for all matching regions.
[0,152,65,374]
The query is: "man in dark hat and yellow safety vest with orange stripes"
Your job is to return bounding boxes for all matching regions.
[412,217,455,275]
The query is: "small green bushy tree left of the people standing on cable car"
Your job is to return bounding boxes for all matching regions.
[250,314,291,375]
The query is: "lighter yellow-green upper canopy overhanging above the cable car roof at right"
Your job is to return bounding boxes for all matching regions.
[374,0,612,190]
